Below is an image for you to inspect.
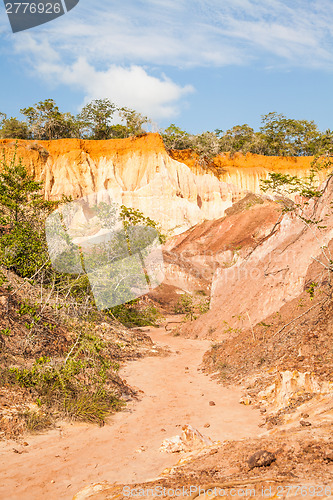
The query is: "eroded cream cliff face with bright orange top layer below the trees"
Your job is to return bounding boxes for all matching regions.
[0,134,320,234]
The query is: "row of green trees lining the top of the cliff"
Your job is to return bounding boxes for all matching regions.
[0,99,333,160]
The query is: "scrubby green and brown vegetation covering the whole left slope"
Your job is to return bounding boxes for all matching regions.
[0,148,162,435]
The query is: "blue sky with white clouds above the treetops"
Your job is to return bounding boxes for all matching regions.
[0,0,333,133]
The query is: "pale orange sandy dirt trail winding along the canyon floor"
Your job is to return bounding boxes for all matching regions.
[0,320,260,500]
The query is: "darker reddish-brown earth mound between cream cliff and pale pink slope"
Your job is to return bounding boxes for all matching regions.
[158,194,281,300]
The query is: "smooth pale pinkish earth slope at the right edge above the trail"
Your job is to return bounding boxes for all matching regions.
[182,179,333,338]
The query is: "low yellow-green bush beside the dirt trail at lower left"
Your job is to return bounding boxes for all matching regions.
[1,334,123,427]
